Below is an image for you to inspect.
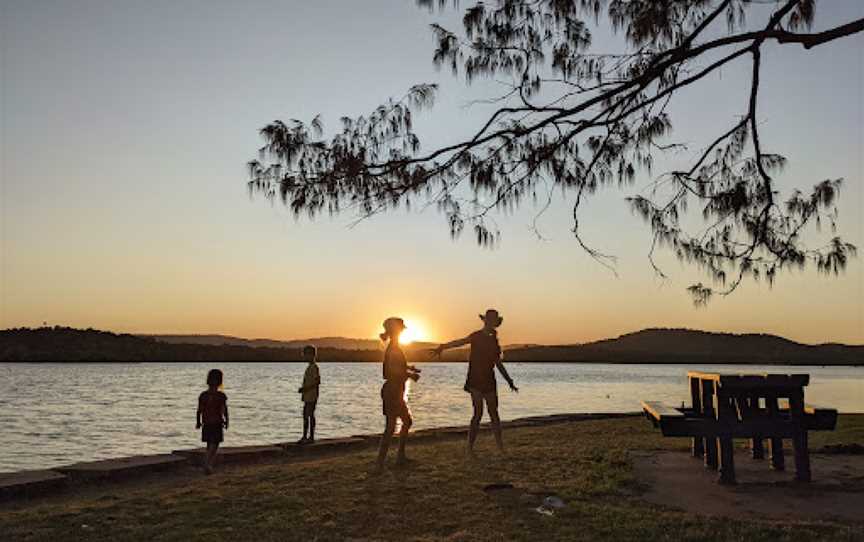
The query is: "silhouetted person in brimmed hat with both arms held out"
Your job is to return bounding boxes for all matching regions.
[433,309,519,455]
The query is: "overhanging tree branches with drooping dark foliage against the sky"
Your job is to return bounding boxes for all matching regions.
[249,0,864,303]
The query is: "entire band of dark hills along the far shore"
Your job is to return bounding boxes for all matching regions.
[0,327,864,365]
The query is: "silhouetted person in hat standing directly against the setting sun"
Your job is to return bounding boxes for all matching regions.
[377,318,420,471]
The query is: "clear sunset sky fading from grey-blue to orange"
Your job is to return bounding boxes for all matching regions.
[0,0,864,343]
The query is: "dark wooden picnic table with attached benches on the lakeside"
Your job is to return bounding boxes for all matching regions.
[642,371,837,484]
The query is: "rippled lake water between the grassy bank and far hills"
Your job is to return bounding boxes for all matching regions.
[0,363,864,472]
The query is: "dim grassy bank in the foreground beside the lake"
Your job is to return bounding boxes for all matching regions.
[0,416,864,542]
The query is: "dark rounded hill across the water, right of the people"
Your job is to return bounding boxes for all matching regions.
[506,329,864,365]
